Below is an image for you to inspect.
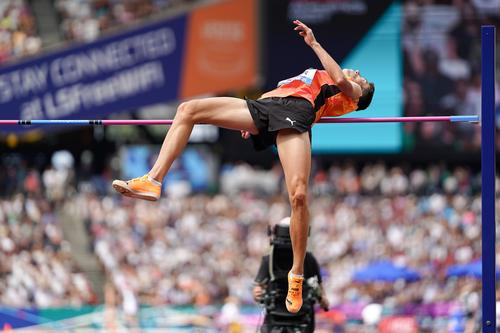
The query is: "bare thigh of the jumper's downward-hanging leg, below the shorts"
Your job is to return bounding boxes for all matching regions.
[276,129,311,189]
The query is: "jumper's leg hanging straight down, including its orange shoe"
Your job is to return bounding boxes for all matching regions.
[276,129,311,312]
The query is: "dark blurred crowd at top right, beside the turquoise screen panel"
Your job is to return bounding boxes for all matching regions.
[402,0,500,151]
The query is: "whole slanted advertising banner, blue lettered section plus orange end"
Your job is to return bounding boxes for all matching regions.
[0,0,257,130]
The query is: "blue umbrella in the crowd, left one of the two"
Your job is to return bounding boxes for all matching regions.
[353,260,420,282]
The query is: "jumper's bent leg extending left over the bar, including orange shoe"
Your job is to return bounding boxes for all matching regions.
[113,97,258,201]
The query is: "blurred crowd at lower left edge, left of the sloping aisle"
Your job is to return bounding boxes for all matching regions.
[0,192,96,308]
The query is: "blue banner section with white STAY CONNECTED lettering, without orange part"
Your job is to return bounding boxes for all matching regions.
[0,15,187,123]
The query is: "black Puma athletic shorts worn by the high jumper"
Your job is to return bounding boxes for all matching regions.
[246,96,316,150]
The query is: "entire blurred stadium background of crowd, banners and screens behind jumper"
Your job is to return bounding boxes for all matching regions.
[0,0,500,333]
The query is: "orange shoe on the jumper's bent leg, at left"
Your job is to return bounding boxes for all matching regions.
[113,175,161,201]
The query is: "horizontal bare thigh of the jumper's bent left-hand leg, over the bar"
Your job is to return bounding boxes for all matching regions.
[189,97,258,134]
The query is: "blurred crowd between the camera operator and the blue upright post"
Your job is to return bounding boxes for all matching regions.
[304,165,481,332]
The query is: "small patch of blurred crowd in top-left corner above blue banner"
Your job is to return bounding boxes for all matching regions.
[0,0,42,65]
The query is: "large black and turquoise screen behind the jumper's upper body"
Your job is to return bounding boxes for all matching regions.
[264,0,402,153]
